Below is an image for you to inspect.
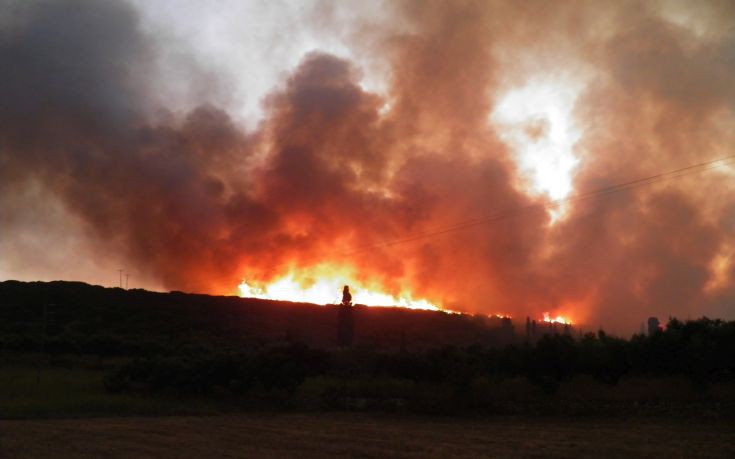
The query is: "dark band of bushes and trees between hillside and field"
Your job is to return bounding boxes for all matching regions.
[102,319,735,393]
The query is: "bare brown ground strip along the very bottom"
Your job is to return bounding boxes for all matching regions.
[0,414,735,458]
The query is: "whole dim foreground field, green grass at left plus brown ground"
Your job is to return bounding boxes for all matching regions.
[0,366,735,459]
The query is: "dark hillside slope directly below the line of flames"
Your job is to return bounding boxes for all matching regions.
[0,281,512,353]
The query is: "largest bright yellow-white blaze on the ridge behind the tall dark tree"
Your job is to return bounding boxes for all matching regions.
[238,274,442,312]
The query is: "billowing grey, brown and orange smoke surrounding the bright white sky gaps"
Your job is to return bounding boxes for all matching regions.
[0,0,735,330]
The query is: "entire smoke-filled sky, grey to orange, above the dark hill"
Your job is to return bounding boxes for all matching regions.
[0,0,735,331]
